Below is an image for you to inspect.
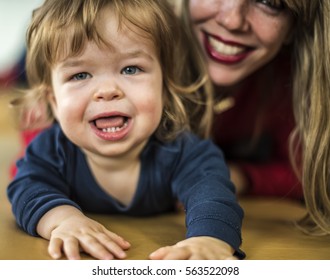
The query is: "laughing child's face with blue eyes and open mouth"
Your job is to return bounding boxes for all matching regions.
[50,6,163,157]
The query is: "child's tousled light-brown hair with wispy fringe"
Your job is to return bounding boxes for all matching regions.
[13,0,212,141]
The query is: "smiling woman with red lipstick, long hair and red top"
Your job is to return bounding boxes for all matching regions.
[178,0,330,235]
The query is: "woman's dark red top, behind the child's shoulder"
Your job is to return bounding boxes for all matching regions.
[214,50,303,199]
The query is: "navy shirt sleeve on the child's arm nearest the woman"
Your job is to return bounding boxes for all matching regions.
[173,136,245,258]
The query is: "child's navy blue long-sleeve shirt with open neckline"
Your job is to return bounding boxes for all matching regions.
[7,124,244,258]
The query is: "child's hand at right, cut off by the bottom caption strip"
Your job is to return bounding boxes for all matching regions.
[149,236,237,260]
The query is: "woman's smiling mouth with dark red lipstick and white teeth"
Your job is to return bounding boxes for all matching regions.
[203,32,254,64]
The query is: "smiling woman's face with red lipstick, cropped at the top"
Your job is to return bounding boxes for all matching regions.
[189,0,293,86]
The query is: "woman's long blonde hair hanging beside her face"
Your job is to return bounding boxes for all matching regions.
[179,0,330,235]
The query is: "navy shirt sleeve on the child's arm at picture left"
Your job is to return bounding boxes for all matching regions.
[7,126,80,236]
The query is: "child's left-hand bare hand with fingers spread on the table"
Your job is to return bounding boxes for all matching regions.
[37,205,130,260]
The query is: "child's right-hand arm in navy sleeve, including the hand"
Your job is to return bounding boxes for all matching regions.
[168,137,245,259]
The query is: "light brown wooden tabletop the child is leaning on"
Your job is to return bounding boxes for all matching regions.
[0,194,330,260]
